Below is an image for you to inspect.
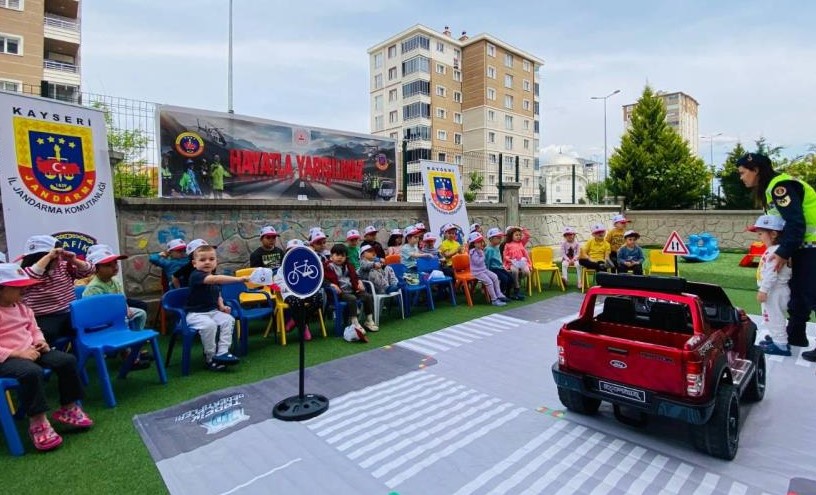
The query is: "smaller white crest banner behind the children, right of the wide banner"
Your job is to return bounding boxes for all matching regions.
[420,160,470,244]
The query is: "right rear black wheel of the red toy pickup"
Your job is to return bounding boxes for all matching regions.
[692,383,740,461]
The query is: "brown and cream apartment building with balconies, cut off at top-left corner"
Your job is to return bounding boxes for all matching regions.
[0,0,81,102]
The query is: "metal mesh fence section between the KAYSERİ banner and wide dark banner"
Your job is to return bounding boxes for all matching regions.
[22,84,160,197]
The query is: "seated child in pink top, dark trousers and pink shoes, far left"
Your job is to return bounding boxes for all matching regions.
[0,263,93,451]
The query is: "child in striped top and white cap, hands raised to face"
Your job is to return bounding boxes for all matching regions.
[20,235,93,345]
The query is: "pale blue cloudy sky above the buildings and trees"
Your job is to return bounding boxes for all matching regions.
[82,0,816,169]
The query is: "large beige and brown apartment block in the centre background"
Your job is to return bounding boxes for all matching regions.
[368,25,544,203]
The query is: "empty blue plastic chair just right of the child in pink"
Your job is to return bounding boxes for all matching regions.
[71,294,167,407]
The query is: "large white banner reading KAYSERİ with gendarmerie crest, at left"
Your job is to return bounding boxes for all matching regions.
[0,92,119,259]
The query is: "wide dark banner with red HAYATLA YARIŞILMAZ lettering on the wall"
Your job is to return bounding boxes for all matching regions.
[156,105,397,201]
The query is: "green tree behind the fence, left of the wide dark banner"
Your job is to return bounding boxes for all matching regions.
[91,101,158,198]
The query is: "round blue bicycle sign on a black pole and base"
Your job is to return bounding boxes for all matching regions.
[272,246,329,421]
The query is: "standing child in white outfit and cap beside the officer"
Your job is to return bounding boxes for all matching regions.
[748,215,792,356]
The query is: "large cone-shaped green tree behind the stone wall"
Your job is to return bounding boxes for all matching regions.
[609,86,711,209]
